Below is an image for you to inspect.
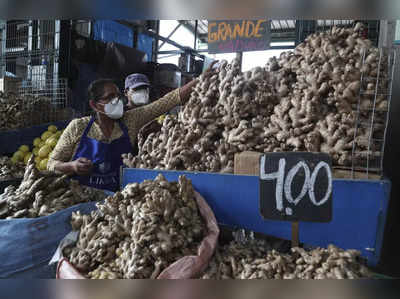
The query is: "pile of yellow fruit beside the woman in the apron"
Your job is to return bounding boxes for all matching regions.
[11,125,63,171]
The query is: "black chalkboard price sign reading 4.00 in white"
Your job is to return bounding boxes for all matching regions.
[260,152,332,222]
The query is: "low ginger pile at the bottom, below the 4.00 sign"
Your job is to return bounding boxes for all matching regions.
[202,240,371,279]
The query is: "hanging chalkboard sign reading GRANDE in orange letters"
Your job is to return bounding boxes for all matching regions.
[208,20,271,54]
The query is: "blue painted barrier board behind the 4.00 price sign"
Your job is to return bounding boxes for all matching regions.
[121,168,390,266]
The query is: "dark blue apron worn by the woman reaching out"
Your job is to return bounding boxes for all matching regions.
[73,116,133,192]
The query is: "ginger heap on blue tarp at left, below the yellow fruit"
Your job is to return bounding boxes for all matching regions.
[0,157,105,219]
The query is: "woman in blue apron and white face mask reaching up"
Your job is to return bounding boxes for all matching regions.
[47,62,219,191]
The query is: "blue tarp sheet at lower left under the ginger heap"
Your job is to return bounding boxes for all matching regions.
[0,202,96,278]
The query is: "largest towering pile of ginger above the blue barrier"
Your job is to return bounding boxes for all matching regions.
[123,23,388,173]
